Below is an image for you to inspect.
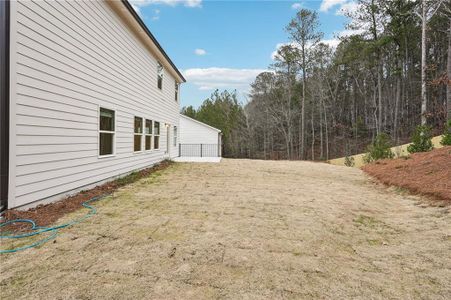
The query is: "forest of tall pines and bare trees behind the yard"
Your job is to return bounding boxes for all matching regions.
[182,0,451,160]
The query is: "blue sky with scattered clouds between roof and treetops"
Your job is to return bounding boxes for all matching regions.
[130,0,355,107]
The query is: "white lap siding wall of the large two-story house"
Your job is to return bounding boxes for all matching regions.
[9,1,180,207]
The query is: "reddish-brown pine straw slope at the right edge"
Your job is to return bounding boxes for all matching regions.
[362,146,451,202]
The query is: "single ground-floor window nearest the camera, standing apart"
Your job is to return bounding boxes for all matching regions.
[99,107,114,156]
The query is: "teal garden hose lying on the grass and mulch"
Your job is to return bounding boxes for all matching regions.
[0,193,111,254]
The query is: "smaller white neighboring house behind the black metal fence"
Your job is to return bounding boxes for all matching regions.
[179,115,222,157]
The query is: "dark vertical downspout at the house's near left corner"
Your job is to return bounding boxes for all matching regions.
[0,0,10,211]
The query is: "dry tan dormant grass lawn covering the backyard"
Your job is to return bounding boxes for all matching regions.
[0,160,451,299]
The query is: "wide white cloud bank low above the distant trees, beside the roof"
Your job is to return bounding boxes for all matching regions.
[183,67,267,92]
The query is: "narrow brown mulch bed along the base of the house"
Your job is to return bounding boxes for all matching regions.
[0,160,172,231]
